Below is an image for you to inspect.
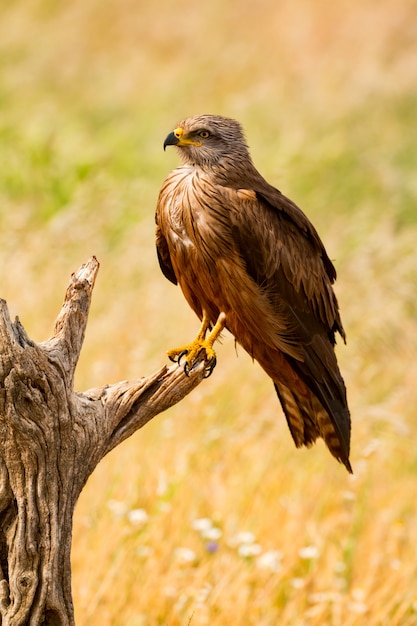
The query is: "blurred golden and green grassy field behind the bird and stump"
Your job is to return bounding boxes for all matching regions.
[0,0,417,626]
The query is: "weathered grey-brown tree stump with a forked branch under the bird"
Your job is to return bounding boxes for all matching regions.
[0,257,208,626]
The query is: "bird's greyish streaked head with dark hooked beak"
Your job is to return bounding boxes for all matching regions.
[164,115,250,167]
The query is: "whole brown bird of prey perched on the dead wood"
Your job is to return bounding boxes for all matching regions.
[156,115,352,472]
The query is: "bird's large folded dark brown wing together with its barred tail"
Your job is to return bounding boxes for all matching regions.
[223,178,350,469]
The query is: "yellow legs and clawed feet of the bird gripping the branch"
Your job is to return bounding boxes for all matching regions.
[168,311,226,378]
